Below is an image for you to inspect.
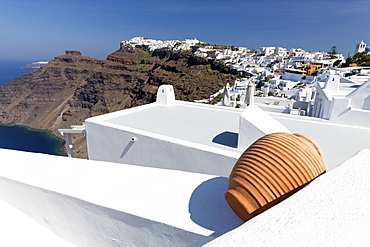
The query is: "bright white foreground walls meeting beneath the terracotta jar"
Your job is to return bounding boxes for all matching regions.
[0,145,370,247]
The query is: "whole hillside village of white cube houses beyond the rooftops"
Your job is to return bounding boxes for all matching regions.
[121,37,370,124]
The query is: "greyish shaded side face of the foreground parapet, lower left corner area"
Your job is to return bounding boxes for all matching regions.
[0,177,207,247]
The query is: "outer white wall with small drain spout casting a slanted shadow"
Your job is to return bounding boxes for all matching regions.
[85,120,240,177]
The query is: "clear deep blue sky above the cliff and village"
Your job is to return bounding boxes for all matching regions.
[0,0,370,61]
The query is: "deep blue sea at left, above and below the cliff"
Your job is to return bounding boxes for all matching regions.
[0,60,64,155]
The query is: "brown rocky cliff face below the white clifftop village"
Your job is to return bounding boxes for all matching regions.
[0,47,235,157]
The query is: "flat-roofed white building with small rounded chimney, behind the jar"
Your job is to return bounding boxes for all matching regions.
[85,85,289,177]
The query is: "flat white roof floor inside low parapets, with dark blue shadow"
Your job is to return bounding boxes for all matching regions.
[106,102,242,154]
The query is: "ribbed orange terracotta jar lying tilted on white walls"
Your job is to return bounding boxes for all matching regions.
[225,133,326,221]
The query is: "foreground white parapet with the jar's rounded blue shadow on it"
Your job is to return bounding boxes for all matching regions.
[0,149,242,247]
